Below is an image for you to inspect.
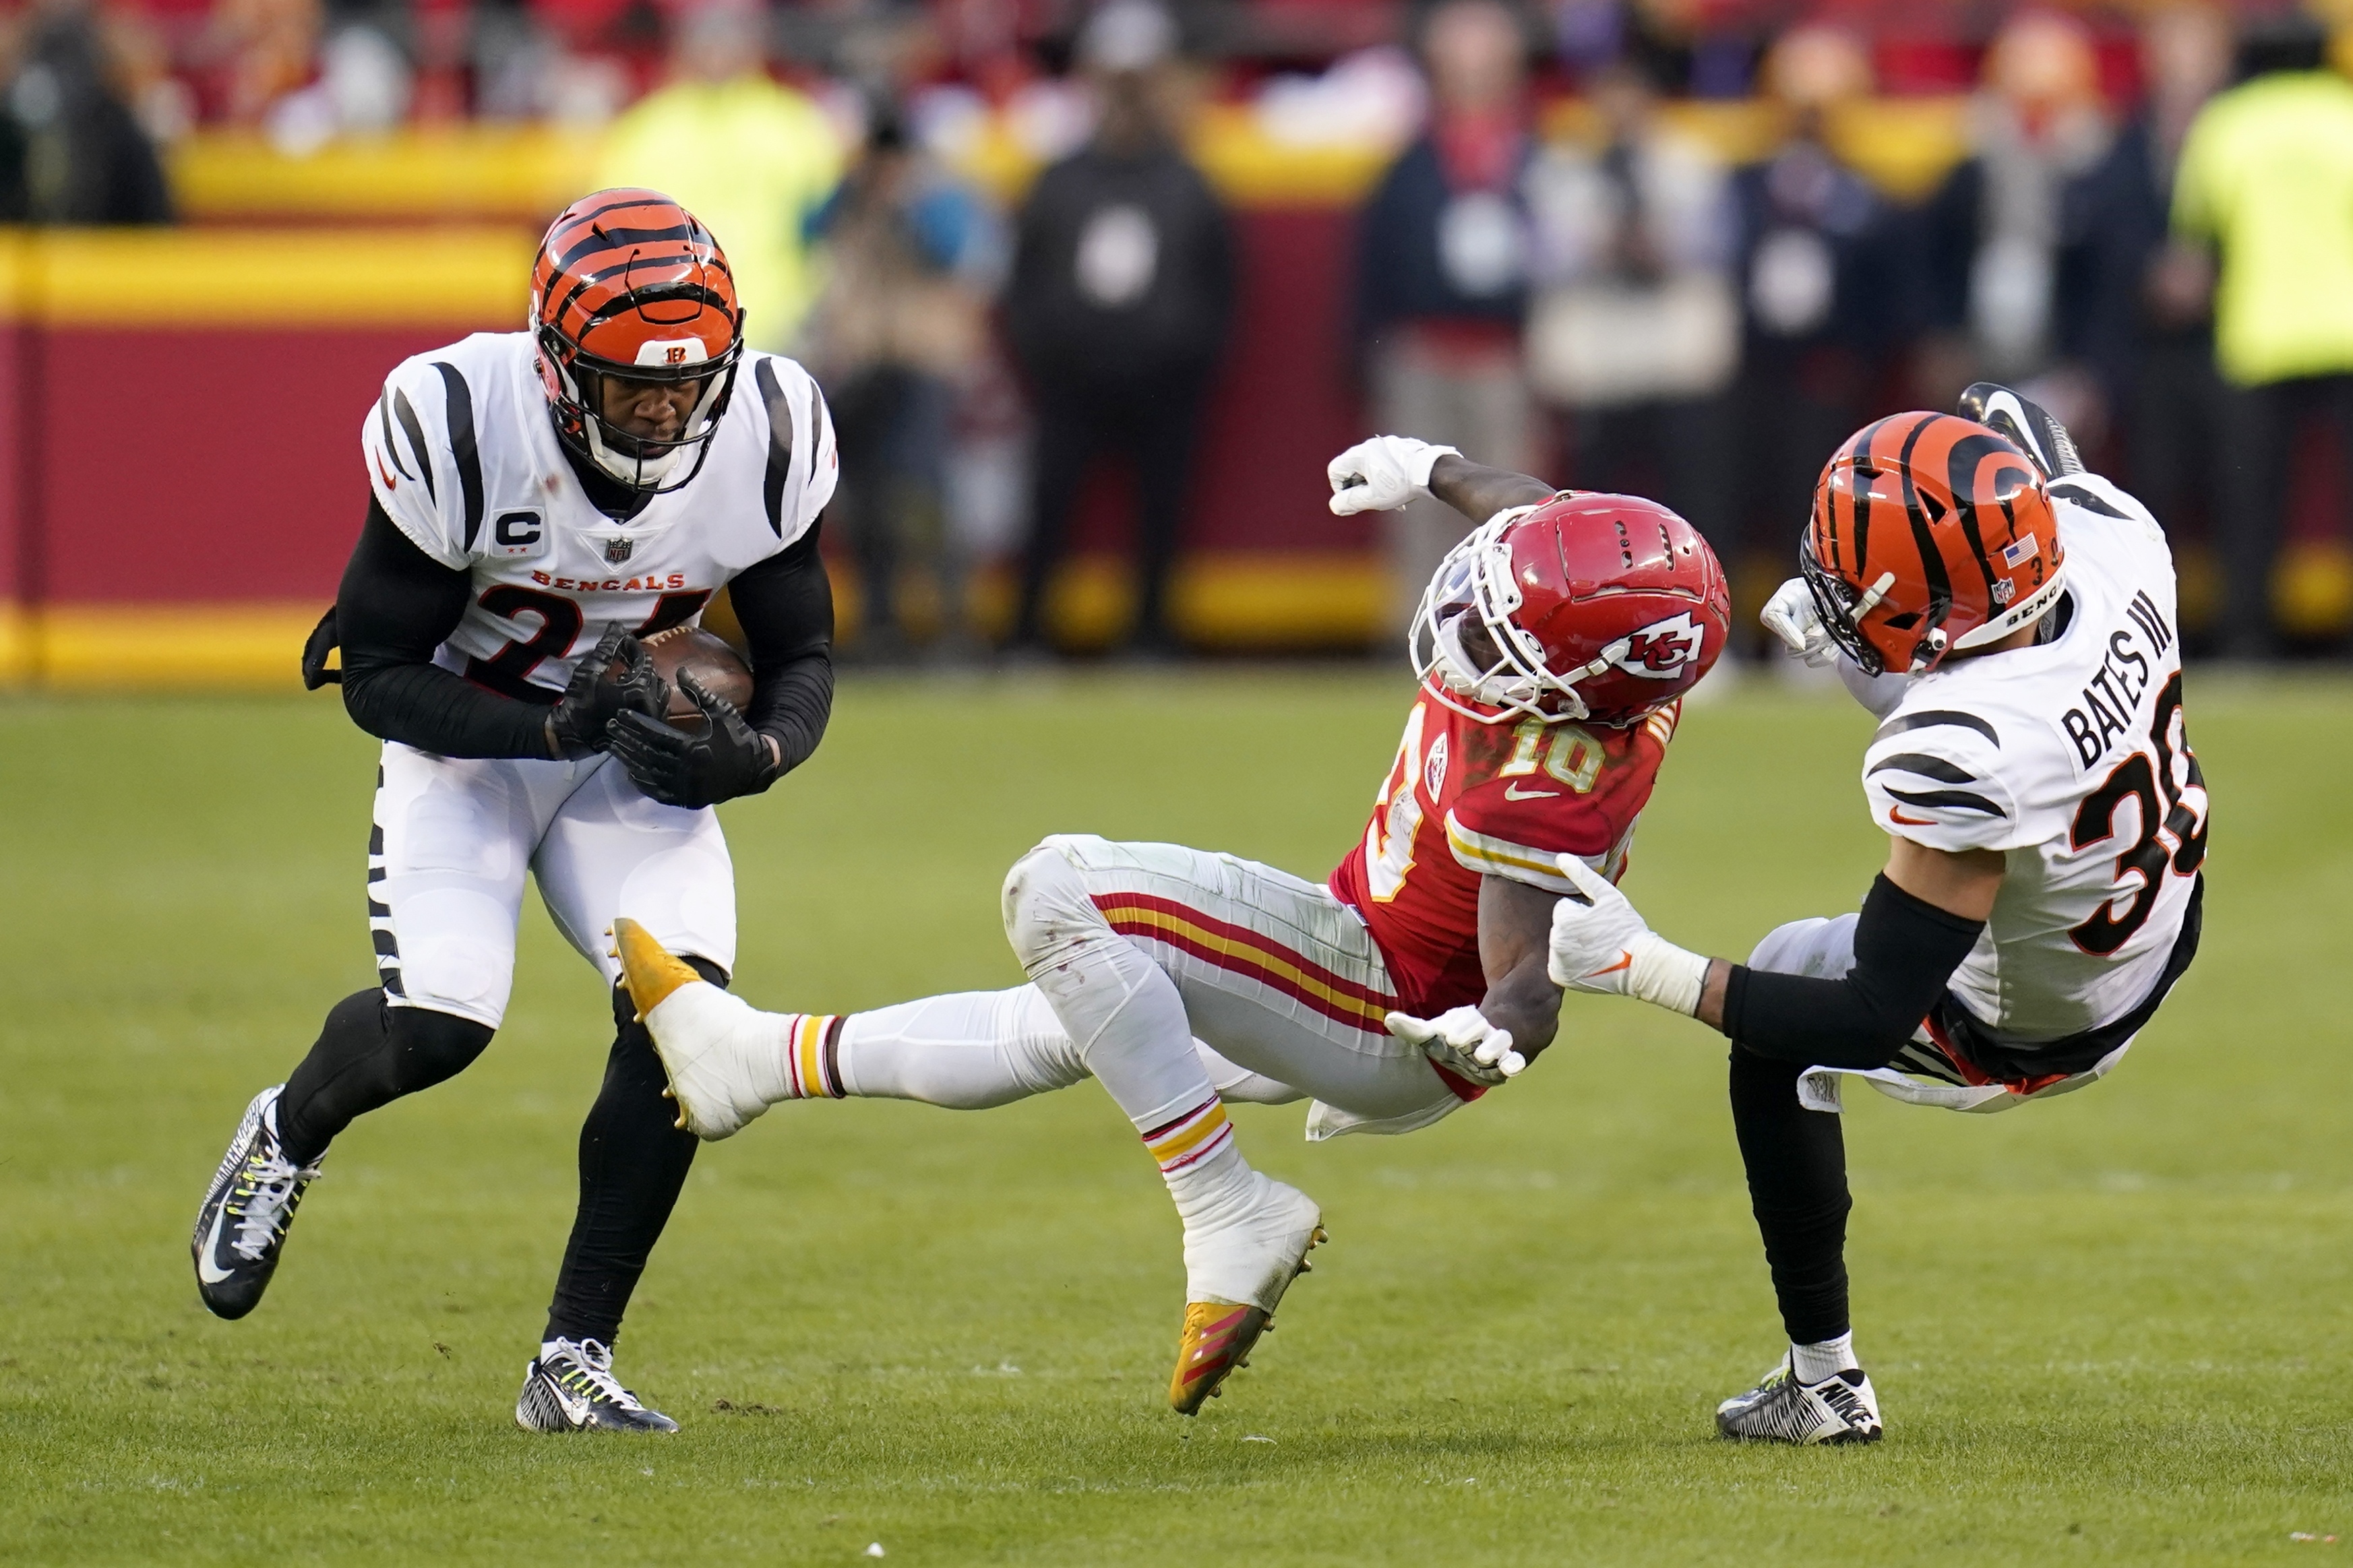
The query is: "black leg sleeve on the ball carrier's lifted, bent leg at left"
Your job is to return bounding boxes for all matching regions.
[278,990,492,1166]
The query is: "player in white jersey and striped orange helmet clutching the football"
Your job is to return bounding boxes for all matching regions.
[193,191,835,1432]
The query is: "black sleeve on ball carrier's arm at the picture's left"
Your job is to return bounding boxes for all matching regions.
[334,499,555,757]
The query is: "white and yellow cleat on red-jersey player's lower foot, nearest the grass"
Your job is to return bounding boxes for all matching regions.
[1169,1170,1324,1415]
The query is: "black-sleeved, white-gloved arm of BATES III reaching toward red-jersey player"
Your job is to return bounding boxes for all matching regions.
[1548,839,2003,1067]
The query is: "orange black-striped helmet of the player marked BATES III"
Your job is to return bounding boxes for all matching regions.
[1798,414,2066,675]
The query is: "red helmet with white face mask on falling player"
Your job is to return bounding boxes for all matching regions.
[1407,491,1732,724]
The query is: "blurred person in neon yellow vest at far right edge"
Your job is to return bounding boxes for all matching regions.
[2174,19,2353,658]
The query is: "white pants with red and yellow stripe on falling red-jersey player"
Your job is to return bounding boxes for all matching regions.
[840,835,1461,1138]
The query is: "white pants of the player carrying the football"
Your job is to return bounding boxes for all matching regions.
[367,741,737,1028]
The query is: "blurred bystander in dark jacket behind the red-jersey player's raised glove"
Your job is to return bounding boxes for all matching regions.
[1355,0,1541,637]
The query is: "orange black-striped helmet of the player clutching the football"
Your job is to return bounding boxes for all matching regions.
[532,188,743,491]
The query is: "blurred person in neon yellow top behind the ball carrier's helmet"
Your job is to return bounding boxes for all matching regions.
[598,0,845,350]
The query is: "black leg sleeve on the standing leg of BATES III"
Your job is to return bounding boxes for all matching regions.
[1732,1044,1854,1345]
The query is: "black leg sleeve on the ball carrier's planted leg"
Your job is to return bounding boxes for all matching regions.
[541,954,727,1345]
